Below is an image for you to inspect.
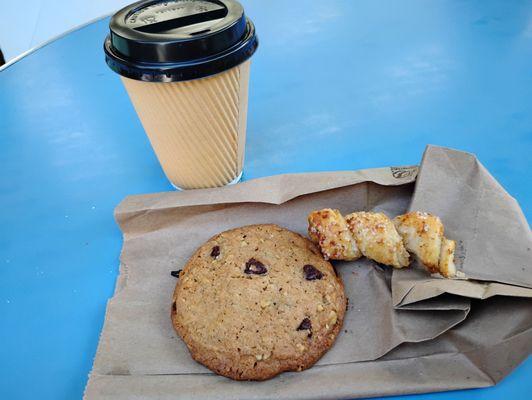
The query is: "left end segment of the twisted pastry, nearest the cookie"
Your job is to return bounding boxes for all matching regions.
[308,208,361,260]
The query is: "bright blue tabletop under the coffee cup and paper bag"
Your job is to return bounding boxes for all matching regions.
[0,0,532,400]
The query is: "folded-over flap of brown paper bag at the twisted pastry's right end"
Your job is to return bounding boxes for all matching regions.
[392,146,532,306]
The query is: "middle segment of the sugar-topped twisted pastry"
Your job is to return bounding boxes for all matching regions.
[345,211,410,268]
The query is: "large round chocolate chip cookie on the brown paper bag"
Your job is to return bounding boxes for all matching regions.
[171,225,346,380]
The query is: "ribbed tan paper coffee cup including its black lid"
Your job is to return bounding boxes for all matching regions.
[104,0,258,189]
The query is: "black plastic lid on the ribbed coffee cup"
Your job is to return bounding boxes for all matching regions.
[104,0,258,82]
